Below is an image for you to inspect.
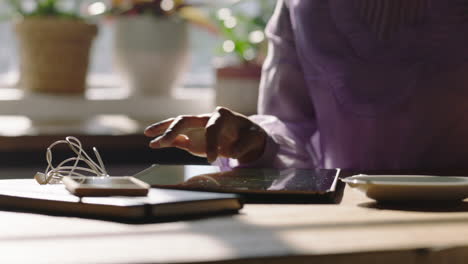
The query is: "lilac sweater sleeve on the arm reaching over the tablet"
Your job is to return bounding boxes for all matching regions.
[216,0,320,169]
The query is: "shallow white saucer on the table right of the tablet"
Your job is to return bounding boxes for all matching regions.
[342,174,468,201]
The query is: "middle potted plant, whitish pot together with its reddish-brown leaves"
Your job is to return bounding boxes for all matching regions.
[110,0,213,96]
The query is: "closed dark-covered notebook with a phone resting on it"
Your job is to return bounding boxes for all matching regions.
[0,179,242,221]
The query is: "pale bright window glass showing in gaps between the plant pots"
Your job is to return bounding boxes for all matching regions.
[0,3,218,87]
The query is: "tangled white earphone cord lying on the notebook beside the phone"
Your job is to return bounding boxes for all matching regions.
[34,136,109,184]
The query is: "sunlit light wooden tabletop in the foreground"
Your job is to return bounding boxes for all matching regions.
[0,186,468,264]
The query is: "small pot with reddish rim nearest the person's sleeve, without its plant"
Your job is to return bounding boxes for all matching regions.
[216,64,262,115]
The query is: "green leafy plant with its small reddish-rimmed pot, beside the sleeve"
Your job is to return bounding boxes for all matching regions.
[214,0,275,115]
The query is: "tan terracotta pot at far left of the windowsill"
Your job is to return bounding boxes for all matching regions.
[15,18,97,94]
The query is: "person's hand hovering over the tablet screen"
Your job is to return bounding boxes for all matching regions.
[145,107,267,163]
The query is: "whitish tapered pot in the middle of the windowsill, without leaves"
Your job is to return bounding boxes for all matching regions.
[114,15,188,96]
